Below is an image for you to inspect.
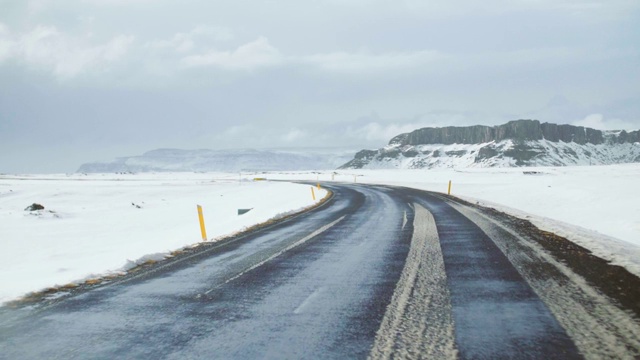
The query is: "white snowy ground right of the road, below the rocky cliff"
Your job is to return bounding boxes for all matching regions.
[268,164,640,276]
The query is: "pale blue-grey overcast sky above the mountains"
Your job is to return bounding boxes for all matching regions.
[0,0,640,173]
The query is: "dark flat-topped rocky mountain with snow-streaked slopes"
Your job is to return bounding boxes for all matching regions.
[341,120,640,169]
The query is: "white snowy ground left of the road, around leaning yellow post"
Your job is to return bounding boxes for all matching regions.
[0,173,326,303]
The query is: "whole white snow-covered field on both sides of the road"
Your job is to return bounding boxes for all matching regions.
[0,164,640,303]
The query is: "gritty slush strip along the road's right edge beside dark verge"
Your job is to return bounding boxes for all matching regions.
[449,201,640,359]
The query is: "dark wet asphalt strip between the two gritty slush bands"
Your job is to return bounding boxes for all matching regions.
[418,193,582,359]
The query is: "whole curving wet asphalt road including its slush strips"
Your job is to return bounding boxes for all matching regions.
[0,184,640,359]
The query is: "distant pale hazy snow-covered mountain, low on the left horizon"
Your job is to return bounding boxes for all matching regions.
[78,149,355,173]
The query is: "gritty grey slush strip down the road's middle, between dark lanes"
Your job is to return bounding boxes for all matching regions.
[369,204,457,359]
